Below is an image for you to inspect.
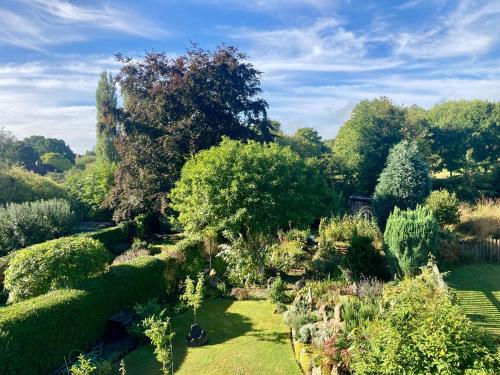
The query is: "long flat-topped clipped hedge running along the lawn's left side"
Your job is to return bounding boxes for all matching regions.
[0,254,179,375]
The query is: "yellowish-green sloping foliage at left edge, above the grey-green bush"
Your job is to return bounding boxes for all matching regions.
[0,167,68,205]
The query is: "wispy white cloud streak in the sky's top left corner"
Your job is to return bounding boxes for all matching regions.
[0,0,168,51]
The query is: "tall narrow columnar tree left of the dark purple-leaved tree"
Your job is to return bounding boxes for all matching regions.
[95,71,118,162]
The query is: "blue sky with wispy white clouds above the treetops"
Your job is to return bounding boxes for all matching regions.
[0,0,500,153]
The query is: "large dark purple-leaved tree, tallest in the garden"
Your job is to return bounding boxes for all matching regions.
[108,46,272,220]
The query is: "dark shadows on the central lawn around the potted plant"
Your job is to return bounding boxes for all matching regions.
[172,298,252,371]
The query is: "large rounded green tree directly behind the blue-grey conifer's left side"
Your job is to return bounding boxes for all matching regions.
[331,98,405,194]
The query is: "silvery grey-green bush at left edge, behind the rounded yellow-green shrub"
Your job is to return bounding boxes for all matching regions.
[0,199,77,254]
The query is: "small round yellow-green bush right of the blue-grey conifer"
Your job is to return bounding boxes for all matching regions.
[425,190,460,227]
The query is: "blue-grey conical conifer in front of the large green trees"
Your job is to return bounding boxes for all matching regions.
[373,141,431,228]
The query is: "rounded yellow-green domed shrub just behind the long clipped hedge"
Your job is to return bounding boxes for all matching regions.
[5,237,111,302]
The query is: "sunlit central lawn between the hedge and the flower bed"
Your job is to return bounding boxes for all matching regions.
[121,299,302,375]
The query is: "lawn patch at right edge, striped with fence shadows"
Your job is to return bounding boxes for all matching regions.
[446,264,500,337]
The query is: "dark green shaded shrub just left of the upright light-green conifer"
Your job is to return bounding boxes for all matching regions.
[341,234,387,280]
